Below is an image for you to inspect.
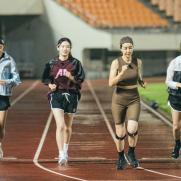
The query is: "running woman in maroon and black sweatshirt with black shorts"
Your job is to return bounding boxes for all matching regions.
[42,38,85,165]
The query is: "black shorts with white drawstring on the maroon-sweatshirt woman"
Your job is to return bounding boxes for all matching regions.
[49,91,79,113]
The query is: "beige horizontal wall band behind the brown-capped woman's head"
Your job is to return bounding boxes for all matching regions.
[112,32,181,51]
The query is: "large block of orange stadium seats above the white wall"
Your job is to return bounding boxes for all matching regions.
[57,0,168,28]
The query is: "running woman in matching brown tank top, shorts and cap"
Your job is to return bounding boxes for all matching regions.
[109,37,145,170]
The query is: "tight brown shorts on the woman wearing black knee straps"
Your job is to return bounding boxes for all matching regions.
[112,88,141,124]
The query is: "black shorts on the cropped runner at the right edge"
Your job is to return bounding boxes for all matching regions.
[168,94,181,111]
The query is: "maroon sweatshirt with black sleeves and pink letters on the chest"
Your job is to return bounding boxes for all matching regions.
[42,57,85,92]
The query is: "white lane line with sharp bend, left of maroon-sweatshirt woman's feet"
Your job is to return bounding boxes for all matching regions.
[33,112,88,181]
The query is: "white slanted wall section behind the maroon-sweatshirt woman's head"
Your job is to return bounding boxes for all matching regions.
[44,0,112,60]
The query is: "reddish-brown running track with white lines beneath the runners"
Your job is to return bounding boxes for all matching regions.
[0,80,181,181]
